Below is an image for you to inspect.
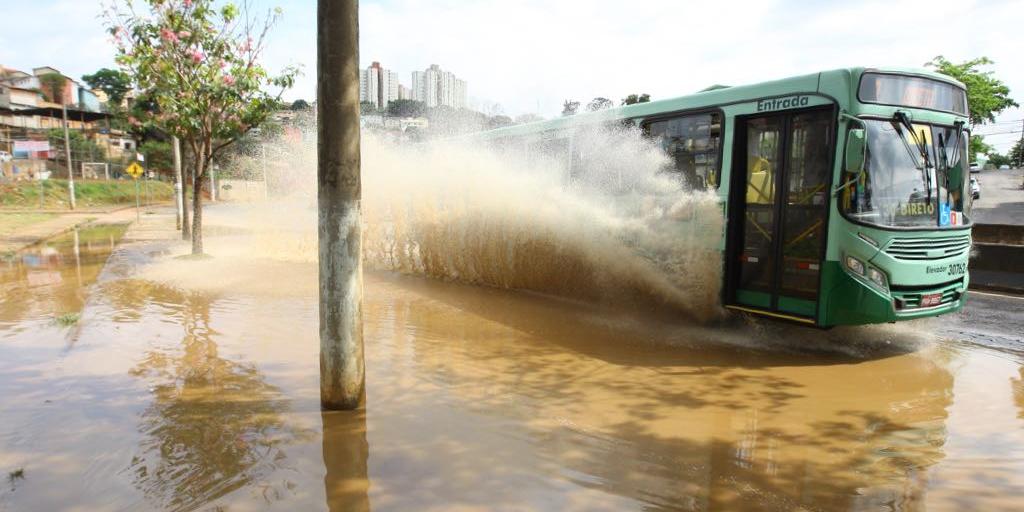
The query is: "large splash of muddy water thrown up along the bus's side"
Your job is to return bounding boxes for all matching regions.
[216,121,723,318]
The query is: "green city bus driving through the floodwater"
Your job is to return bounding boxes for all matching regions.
[482,68,972,328]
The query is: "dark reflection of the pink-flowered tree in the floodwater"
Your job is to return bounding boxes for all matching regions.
[128,282,310,510]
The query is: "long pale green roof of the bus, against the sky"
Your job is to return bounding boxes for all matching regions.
[472,68,965,138]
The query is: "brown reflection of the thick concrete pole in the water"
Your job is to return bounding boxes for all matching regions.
[321,411,370,512]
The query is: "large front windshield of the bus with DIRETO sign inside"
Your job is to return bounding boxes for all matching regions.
[840,120,971,227]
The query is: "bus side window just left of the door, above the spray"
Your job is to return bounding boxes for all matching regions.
[644,113,722,189]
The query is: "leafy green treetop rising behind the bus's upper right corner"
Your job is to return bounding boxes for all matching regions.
[926,55,1019,125]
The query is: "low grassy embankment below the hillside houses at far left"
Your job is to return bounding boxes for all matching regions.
[0,179,174,210]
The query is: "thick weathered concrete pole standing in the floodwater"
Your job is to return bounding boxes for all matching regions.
[316,0,366,410]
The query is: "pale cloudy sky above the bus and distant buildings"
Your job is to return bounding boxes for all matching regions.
[0,0,1024,152]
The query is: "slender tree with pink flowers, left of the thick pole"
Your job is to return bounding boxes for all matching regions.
[106,0,298,255]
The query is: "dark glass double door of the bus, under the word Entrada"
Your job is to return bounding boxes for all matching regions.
[726,109,835,323]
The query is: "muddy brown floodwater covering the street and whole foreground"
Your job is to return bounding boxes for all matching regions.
[0,217,1024,511]
